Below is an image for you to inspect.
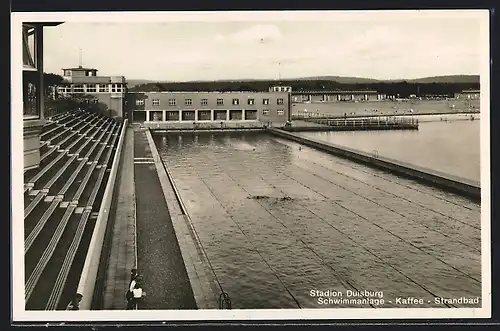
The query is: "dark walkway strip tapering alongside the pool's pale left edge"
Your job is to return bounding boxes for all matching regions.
[132,129,197,309]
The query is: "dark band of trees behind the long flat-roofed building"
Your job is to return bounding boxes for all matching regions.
[129,80,479,98]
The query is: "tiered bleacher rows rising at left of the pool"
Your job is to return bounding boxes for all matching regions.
[24,110,122,310]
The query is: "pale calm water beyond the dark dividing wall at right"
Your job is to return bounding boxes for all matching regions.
[301,116,480,181]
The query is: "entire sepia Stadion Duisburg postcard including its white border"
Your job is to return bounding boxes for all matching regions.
[11,10,491,321]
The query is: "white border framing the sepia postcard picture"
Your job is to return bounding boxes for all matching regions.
[11,10,491,322]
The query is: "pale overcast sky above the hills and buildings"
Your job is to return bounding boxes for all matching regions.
[34,11,481,81]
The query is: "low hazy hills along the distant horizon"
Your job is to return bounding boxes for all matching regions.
[127,75,479,88]
